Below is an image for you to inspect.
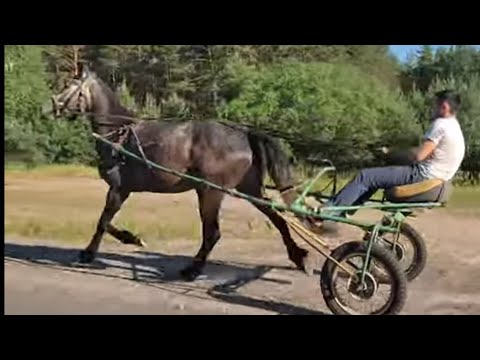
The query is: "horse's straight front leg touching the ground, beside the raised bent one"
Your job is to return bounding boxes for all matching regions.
[79,188,130,263]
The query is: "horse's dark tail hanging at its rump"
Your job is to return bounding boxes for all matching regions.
[248,130,295,205]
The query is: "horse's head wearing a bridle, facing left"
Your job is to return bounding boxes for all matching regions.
[52,66,95,120]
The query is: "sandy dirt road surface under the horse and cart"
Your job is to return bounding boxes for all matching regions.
[5,186,480,315]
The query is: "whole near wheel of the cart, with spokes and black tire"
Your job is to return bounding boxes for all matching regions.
[320,242,407,315]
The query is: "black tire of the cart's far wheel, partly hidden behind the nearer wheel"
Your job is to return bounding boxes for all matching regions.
[380,223,428,281]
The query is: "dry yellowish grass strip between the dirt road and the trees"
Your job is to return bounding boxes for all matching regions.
[4,165,480,244]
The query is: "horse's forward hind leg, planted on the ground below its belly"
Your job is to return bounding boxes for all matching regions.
[180,190,224,281]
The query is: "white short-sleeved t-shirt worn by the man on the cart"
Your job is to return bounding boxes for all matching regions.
[420,117,465,181]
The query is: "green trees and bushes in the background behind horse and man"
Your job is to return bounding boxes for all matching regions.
[4,45,480,181]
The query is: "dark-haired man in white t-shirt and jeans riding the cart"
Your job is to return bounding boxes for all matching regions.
[326,90,465,216]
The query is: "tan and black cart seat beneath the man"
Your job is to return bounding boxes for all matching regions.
[385,179,451,203]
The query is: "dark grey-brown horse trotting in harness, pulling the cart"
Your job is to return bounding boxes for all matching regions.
[52,67,312,281]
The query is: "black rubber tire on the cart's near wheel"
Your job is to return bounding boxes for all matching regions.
[320,242,408,315]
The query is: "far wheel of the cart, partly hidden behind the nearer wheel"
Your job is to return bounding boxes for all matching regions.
[379,223,428,281]
